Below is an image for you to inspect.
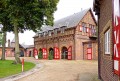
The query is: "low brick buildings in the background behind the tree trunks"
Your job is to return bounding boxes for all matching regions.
[0,39,34,57]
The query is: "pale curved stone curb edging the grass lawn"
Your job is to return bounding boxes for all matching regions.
[0,63,43,81]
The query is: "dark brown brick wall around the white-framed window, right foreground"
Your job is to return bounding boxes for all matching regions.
[99,0,119,81]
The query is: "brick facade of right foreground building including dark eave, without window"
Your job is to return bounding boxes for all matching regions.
[94,0,119,81]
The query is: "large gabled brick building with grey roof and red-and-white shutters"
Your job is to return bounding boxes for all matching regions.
[34,9,97,60]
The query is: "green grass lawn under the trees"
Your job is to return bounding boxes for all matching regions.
[0,60,35,78]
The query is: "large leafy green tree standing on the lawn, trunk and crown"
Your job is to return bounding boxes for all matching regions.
[0,0,59,63]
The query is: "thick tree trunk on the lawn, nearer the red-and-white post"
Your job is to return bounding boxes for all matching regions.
[14,23,21,64]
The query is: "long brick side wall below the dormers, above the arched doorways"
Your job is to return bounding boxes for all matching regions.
[34,28,75,59]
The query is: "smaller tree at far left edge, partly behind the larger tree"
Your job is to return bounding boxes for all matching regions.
[0,1,13,60]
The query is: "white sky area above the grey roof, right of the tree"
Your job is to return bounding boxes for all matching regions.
[54,0,93,20]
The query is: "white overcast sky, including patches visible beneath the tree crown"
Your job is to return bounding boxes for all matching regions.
[7,0,93,45]
